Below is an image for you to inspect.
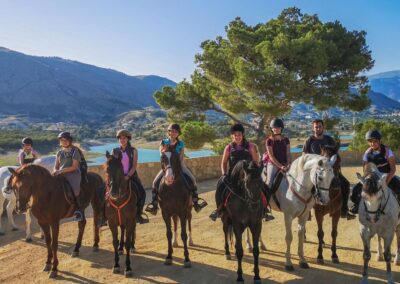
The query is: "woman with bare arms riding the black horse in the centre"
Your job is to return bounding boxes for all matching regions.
[210,123,266,221]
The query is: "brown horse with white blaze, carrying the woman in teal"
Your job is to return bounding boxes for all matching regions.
[158,151,191,268]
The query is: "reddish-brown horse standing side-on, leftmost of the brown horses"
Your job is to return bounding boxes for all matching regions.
[9,165,104,278]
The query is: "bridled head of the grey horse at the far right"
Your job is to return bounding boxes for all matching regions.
[357,165,389,223]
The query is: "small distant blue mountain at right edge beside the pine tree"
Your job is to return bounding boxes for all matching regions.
[368,71,400,102]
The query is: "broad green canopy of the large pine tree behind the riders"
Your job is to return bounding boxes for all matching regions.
[154,8,373,151]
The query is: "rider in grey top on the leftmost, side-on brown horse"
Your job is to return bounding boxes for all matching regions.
[53,132,85,222]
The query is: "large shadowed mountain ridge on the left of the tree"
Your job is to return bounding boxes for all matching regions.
[0,48,176,123]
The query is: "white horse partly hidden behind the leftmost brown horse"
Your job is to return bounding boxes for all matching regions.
[0,155,56,242]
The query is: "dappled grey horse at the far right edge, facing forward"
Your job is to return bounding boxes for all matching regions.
[357,163,400,283]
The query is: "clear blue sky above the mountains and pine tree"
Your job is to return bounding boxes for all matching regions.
[0,0,400,82]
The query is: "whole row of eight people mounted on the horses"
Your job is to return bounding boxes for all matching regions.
[14,118,400,224]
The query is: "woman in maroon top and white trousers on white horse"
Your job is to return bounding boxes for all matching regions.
[263,118,290,206]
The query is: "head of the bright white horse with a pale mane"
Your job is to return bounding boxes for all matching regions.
[304,154,337,205]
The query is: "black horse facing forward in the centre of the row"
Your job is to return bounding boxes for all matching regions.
[221,160,264,283]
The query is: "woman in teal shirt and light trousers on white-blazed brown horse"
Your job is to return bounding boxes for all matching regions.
[146,123,207,215]
